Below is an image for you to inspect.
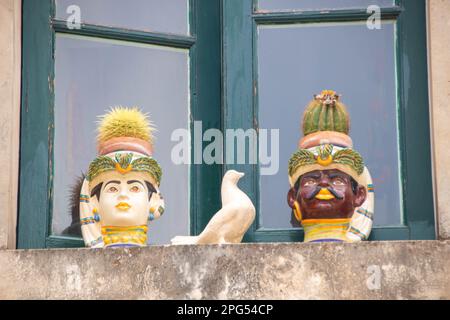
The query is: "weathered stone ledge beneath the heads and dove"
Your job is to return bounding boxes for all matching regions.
[0,241,450,299]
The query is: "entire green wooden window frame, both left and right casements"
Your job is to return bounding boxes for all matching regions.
[17,0,436,248]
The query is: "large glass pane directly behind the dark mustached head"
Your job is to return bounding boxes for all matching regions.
[258,23,401,228]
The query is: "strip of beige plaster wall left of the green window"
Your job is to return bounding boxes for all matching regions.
[0,0,21,249]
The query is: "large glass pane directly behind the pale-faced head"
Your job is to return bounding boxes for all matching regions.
[53,34,189,244]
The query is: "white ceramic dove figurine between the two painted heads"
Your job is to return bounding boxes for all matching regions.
[171,170,255,244]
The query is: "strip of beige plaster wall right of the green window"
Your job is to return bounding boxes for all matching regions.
[428,0,450,239]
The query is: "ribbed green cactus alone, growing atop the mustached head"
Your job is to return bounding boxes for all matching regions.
[303,90,350,136]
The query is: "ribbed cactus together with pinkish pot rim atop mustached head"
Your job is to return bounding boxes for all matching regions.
[298,90,353,149]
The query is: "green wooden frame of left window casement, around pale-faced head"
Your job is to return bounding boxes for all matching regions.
[17,0,222,248]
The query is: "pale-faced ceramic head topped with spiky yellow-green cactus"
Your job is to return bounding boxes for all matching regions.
[80,107,164,247]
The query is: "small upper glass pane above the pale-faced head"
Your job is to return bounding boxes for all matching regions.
[56,0,189,34]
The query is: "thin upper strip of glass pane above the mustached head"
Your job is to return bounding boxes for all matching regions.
[258,0,394,11]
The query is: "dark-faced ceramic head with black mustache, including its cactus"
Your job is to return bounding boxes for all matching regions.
[287,90,373,242]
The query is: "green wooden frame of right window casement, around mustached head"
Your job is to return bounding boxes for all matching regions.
[222,0,436,242]
